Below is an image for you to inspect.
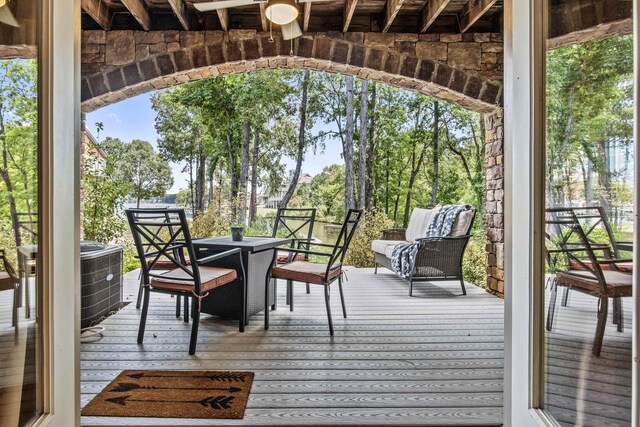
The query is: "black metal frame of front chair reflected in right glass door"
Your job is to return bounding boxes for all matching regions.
[546,208,630,356]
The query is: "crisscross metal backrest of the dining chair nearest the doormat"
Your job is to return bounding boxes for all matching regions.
[126,208,201,295]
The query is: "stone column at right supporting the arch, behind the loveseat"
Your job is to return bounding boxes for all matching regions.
[484,109,504,295]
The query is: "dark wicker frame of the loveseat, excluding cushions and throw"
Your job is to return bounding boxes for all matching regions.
[374,209,476,296]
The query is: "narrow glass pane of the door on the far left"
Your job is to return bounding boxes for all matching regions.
[0,0,43,427]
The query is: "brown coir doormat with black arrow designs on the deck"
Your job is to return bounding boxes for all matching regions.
[82,370,253,419]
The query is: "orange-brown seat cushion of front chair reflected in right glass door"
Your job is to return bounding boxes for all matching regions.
[557,270,633,297]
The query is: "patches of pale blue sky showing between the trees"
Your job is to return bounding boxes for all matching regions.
[86,93,344,193]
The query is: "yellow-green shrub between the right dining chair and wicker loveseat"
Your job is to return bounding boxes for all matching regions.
[344,209,393,268]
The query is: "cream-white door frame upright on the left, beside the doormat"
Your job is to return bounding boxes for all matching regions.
[36,0,80,427]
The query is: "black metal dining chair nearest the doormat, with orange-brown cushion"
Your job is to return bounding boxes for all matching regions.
[126,209,247,355]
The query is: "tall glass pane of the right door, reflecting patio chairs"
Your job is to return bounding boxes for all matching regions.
[539,0,635,426]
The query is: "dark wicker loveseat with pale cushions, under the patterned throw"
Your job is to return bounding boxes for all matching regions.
[371,207,476,295]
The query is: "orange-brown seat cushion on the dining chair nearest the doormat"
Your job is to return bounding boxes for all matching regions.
[151,267,238,292]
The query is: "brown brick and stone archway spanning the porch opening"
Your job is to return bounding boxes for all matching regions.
[82,30,502,113]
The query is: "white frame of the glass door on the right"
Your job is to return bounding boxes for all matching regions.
[504,0,640,427]
